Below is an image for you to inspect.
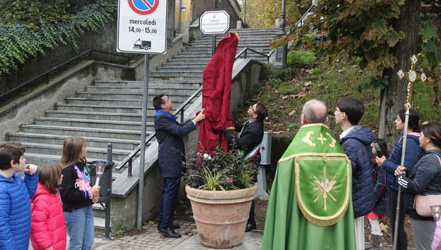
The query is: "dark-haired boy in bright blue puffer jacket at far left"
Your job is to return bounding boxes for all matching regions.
[0,142,38,250]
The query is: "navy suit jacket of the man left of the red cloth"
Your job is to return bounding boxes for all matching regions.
[155,111,196,178]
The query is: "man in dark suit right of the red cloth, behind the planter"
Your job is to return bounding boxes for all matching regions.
[225,102,268,232]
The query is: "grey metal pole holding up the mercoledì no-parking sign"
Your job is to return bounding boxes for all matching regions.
[136,54,149,230]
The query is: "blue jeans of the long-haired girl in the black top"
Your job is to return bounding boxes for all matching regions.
[64,206,94,250]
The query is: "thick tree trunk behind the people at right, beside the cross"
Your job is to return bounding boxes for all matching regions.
[378,0,421,150]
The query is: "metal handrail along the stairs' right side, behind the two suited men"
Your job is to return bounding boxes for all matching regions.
[115,47,275,177]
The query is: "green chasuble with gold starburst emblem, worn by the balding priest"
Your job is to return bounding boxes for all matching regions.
[262,124,356,250]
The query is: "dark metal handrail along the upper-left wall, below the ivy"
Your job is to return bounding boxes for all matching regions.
[0,49,130,101]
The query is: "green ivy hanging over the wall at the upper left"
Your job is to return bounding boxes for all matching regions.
[0,0,118,75]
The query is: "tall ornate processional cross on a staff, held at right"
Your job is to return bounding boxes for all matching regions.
[393,55,427,250]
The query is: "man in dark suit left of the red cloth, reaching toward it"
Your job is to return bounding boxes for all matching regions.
[153,94,205,238]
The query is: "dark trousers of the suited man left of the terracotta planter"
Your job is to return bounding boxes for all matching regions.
[158,178,180,229]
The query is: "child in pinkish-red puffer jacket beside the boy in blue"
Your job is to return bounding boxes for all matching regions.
[31,164,66,250]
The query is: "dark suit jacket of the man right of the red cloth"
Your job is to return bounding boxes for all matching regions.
[225,121,263,155]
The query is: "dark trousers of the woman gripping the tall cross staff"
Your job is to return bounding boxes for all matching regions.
[389,189,407,250]
